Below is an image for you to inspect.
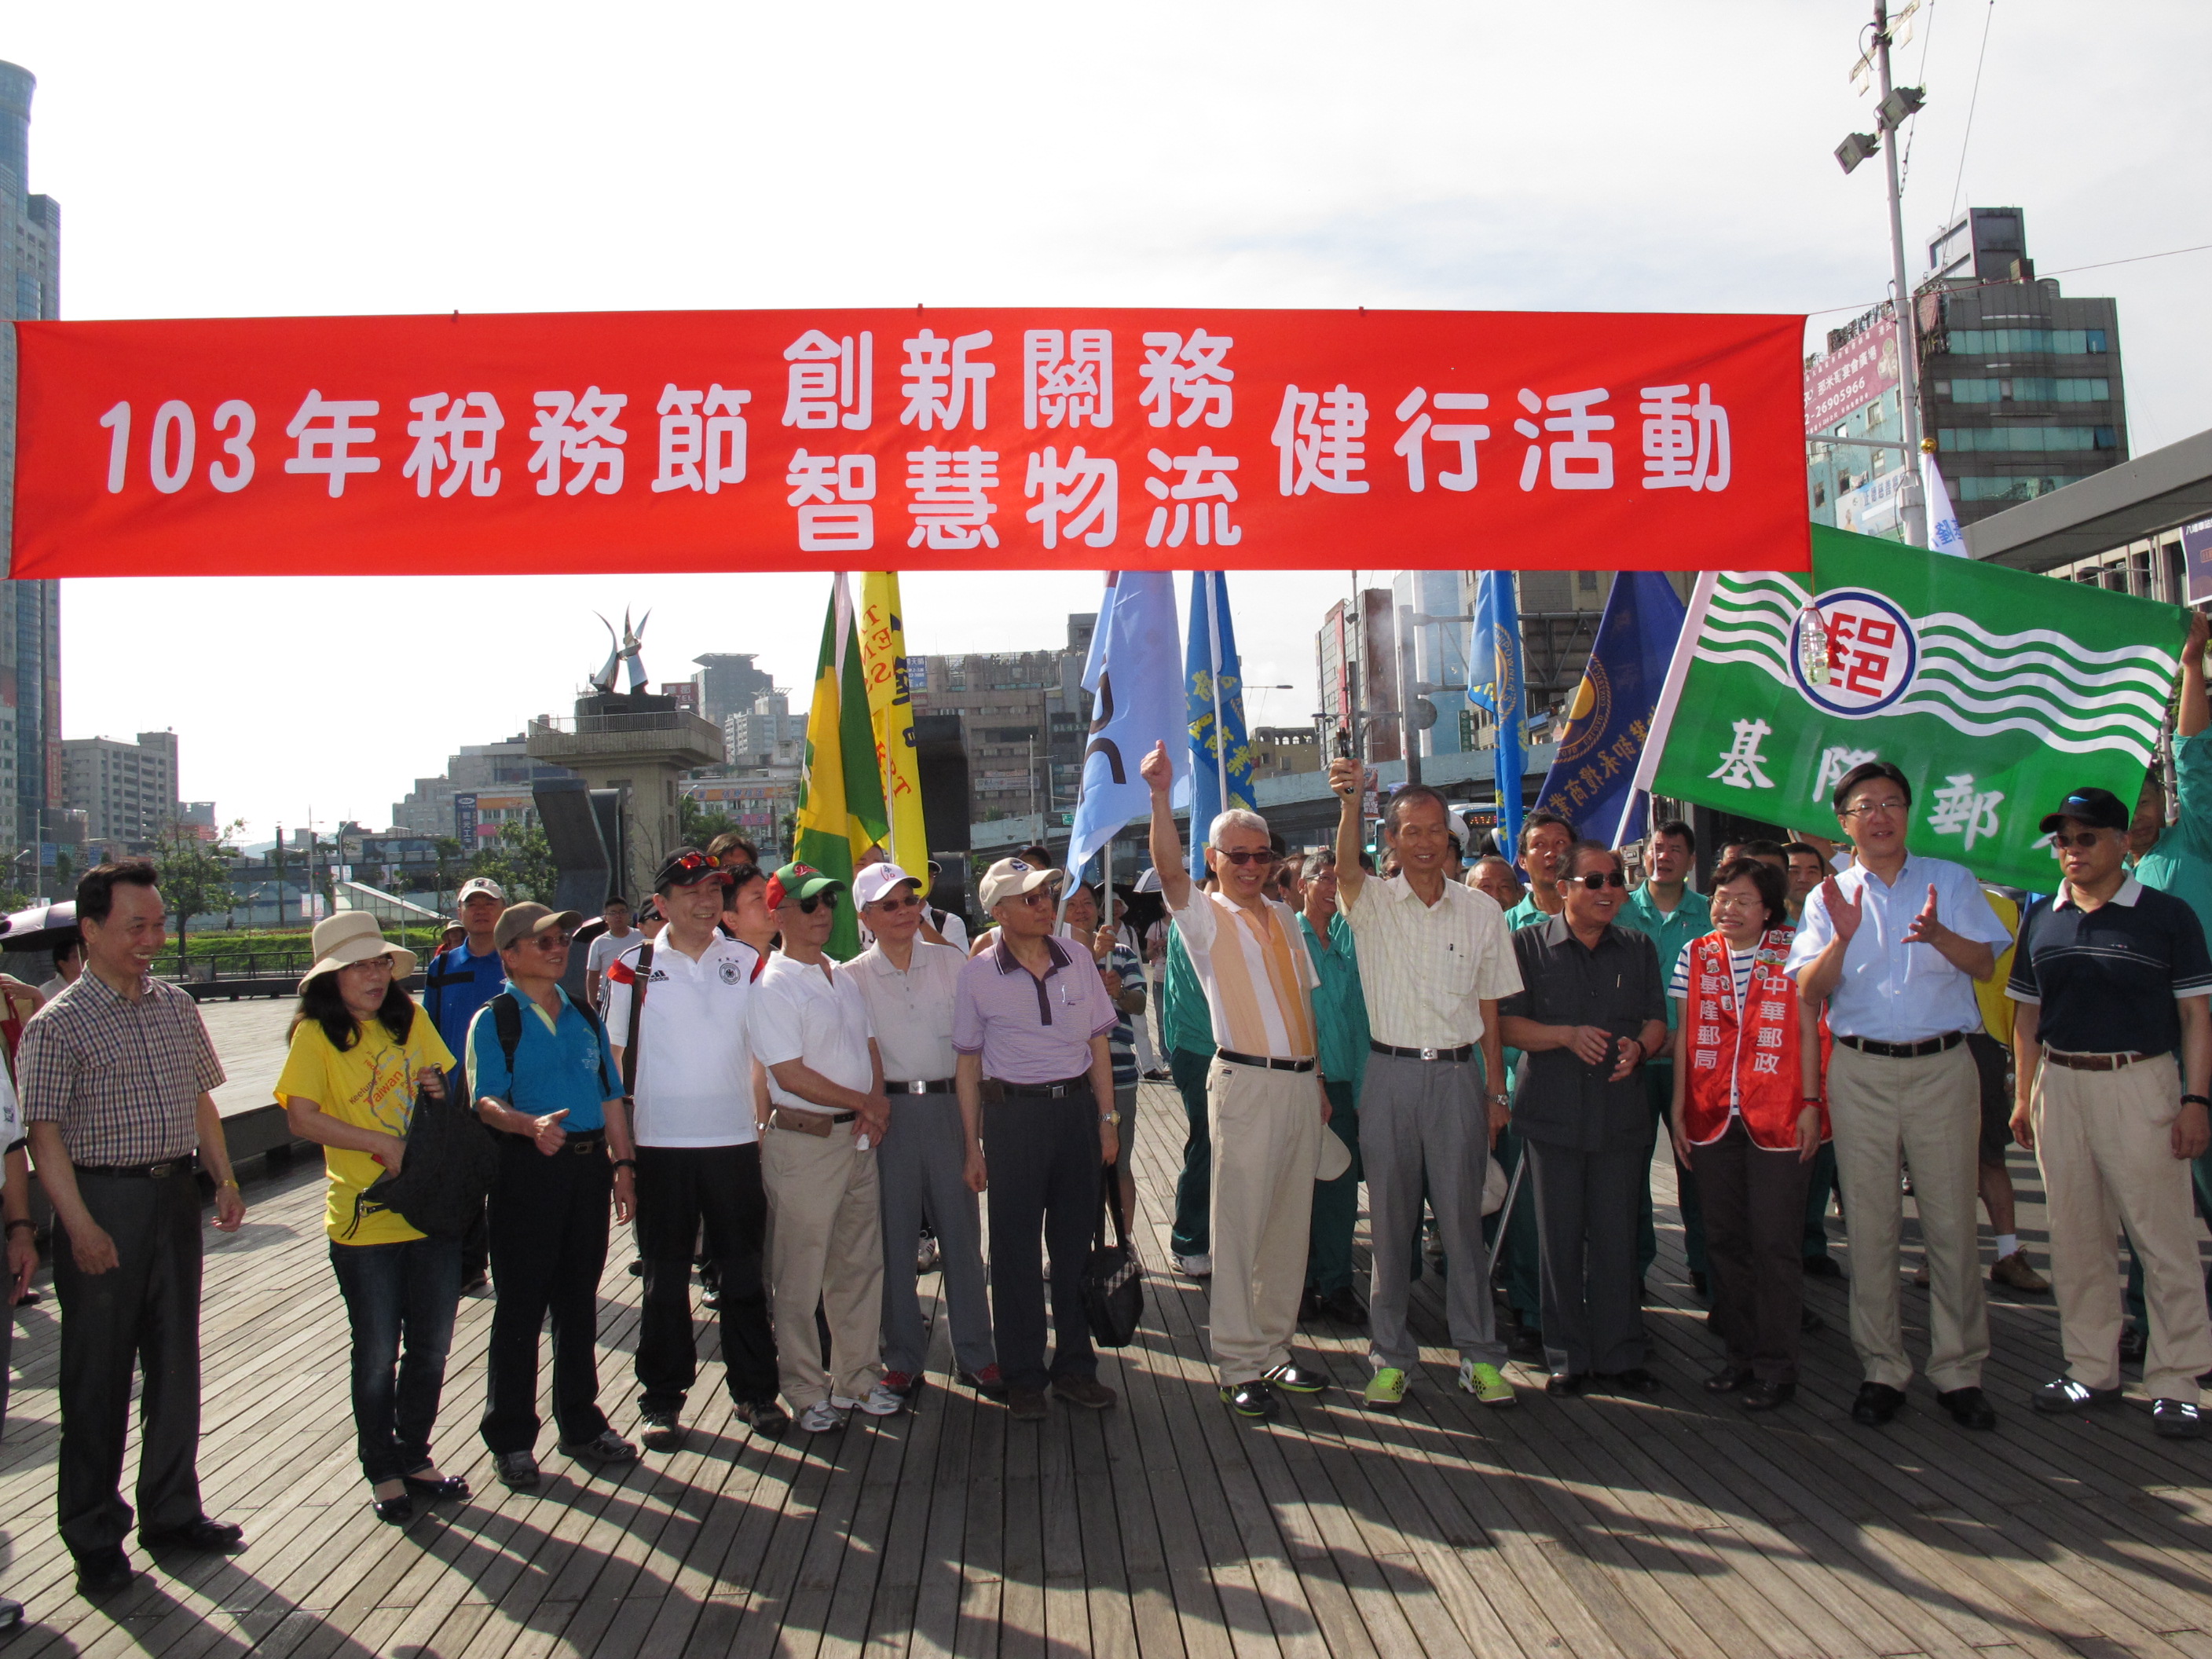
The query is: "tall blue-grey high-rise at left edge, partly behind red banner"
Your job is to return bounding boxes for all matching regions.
[0,64,66,876]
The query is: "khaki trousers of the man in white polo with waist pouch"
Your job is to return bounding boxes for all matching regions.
[761,1124,883,1413]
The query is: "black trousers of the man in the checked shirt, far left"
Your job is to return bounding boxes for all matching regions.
[53,1170,199,1555]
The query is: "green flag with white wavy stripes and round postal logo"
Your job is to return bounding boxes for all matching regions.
[1637,526,2188,892]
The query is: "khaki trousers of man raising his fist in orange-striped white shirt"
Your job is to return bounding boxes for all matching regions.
[1206,1060,1325,1387]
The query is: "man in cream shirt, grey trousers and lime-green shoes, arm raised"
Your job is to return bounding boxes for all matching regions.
[1329,759,1522,1412]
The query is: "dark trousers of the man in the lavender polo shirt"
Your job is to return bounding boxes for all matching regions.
[982,1088,1100,1389]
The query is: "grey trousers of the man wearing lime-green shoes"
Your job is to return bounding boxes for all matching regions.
[1361,1051,1507,1372]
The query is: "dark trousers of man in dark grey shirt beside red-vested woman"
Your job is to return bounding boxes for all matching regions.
[1526,1139,1653,1374]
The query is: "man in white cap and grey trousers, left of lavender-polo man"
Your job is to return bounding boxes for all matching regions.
[836,862,1004,1398]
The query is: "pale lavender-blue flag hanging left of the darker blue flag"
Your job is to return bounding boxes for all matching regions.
[1068,571,1190,884]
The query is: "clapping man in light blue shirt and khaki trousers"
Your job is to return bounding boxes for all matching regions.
[1787,761,2013,1429]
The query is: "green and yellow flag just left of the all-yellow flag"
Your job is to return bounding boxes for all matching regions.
[792,575,892,962]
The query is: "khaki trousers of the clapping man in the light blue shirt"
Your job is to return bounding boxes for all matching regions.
[1827,1042,1989,1393]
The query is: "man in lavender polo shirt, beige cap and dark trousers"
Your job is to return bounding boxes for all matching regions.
[954,859,1122,1423]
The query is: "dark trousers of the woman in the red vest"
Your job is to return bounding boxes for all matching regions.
[1690,1117,1811,1382]
